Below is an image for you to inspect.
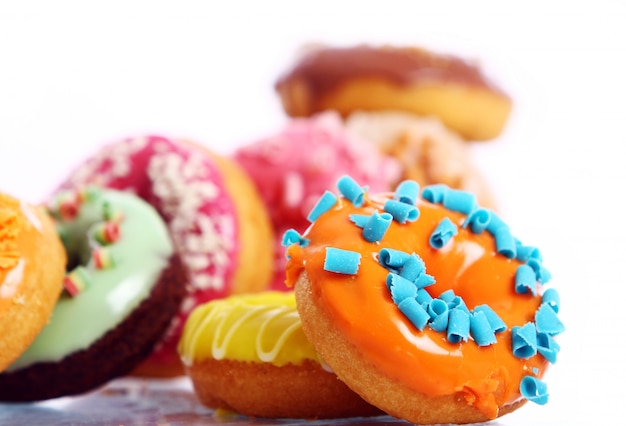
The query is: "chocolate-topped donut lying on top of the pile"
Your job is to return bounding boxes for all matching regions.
[275,45,512,141]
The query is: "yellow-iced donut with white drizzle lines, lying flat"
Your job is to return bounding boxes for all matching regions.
[179,291,381,419]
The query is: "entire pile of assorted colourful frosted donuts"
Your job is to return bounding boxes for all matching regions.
[0,45,564,424]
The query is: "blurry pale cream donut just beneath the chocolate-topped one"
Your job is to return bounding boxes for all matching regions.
[344,111,498,209]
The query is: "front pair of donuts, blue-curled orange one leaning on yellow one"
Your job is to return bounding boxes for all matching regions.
[179,176,565,424]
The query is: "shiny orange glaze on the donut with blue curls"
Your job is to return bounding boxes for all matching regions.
[287,195,547,418]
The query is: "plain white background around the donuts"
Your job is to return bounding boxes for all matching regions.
[0,0,626,425]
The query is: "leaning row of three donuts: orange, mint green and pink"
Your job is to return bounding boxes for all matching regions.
[0,135,274,401]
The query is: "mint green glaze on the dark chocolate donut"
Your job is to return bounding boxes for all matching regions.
[8,191,173,371]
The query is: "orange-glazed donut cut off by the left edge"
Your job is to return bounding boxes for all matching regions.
[0,193,66,372]
